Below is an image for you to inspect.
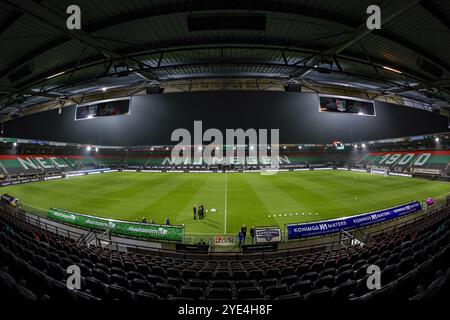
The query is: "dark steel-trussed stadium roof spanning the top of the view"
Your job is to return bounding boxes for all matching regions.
[0,0,450,118]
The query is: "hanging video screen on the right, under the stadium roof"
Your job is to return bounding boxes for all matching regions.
[319,95,375,116]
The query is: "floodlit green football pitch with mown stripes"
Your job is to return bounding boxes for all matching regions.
[2,171,450,236]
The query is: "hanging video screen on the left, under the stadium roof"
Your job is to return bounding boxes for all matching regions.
[75,98,130,120]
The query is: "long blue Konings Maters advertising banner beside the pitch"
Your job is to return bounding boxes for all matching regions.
[286,201,422,240]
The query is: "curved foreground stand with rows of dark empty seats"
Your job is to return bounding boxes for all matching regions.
[0,202,450,301]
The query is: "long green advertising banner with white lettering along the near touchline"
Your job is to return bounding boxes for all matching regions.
[47,208,184,241]
